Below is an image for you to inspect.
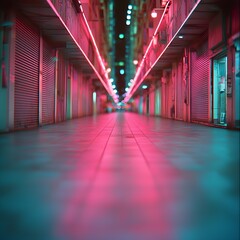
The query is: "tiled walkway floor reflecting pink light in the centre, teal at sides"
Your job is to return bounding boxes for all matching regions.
[0,113,239,240]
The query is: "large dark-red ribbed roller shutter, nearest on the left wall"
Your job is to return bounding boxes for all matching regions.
[14,17,40,129]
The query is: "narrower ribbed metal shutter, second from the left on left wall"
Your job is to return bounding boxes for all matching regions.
[42,41,55,124]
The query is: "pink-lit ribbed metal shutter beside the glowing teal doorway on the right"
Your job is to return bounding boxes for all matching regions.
[191,42,209,122]
